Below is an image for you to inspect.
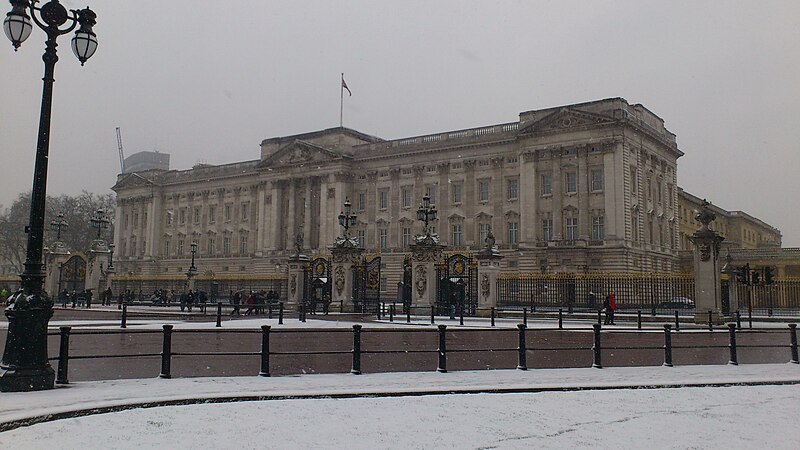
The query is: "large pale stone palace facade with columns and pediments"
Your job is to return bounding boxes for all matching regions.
[113,98,683,286]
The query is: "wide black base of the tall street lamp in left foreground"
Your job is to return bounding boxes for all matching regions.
[0,291,56,392]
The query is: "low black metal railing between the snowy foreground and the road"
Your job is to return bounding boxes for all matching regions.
[49,323,800,384]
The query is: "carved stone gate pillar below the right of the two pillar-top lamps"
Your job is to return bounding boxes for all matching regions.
[411,241,444,307]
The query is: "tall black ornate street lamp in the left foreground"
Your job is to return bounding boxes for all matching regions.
[0,0,97,392]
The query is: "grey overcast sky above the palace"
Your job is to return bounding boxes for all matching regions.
[0,0,800,247]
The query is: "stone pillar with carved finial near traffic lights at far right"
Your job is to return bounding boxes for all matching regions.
[689,200,724,324]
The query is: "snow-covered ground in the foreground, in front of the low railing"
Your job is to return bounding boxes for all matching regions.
[0,364,800,449]
